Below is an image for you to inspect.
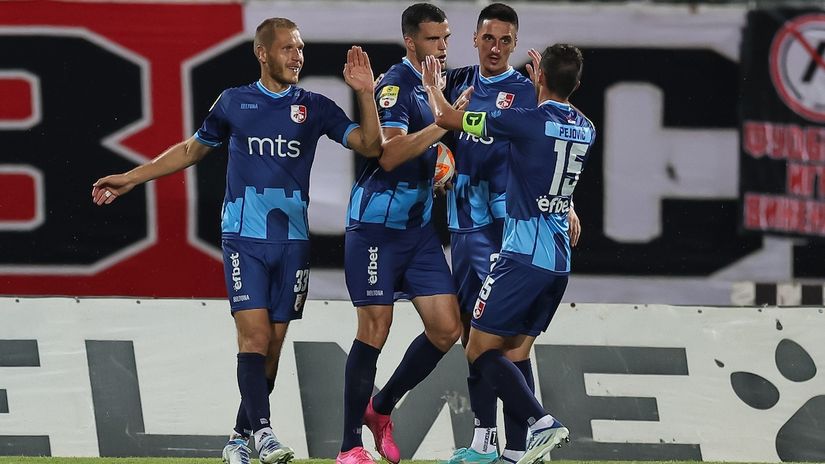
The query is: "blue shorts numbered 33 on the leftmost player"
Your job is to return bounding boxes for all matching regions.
[222,240,309,322]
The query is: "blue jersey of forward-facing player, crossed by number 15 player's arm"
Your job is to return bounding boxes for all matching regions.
[447,65,536,233]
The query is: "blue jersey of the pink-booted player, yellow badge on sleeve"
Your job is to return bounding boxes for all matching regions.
[347,58,437,230]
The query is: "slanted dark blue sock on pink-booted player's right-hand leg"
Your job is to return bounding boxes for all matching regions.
[372,333,445,414]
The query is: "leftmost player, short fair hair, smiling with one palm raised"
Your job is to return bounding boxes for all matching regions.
[92,18,383,464]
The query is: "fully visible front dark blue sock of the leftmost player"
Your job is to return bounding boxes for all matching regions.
[238,353,269,432]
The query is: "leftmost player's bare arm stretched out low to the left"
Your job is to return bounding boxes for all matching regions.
[92,136,212,205]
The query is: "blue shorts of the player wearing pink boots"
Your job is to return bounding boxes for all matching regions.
[344,225,455,307]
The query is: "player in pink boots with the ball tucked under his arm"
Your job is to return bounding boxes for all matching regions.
[336,3,470,464]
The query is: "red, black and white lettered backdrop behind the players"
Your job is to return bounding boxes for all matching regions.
[0,2,825,304]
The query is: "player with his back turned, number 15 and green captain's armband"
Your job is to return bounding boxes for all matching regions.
[422,44,595,464]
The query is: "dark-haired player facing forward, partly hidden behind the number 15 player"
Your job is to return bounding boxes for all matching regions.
[445,3,536,464]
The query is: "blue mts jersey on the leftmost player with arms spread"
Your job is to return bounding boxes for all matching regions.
[195,81,358,242]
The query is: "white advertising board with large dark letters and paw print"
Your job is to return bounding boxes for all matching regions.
[0,298,825,462]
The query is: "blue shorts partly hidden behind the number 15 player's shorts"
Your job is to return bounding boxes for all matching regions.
[450,227,501,313]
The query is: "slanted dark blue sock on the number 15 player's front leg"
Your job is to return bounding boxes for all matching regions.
[473,350,547,425]
